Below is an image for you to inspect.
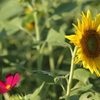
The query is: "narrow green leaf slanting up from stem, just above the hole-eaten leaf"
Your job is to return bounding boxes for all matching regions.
[70,84,93,96]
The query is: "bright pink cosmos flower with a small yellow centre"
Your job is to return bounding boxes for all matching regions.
[0,73,20,93]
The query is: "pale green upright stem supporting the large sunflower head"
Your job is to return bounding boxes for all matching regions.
[65,47,77,100]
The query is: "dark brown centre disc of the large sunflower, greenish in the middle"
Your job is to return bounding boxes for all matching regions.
[81,30,100,58]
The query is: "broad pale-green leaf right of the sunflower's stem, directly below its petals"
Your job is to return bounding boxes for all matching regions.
[73,68,91,84]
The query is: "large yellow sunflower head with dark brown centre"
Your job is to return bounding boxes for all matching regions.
[65,10,100,76]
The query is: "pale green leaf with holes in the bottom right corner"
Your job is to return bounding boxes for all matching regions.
[79,92,100,100]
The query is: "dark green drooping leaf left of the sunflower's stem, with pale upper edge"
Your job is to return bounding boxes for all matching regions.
[29,70,55,84]
